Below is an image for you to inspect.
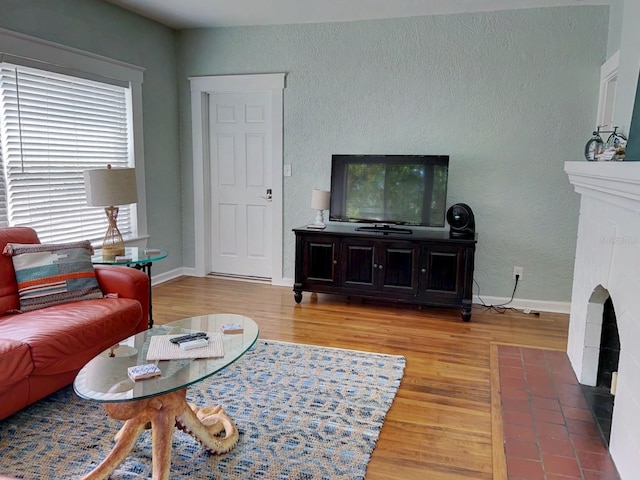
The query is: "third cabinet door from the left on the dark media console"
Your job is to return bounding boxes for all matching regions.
[377,242,420,296]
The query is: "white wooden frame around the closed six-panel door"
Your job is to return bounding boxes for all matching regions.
[189,73,286,285]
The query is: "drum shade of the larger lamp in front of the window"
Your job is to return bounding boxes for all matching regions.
[84,165,138,207]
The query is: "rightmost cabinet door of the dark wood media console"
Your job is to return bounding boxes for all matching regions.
[420,247,465,304]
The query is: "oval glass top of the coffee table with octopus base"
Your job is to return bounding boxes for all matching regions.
[73,313,259,402]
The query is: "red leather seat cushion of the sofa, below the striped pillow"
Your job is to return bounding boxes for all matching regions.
[0,298,146,378]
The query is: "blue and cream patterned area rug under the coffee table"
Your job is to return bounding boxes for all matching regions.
[0,340,405,480]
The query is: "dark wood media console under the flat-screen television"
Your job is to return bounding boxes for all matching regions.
[293,224,477,322]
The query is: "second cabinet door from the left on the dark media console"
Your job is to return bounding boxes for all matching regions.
[340,239,378,290]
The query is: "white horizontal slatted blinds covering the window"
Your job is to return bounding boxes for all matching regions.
[0,63,135,243]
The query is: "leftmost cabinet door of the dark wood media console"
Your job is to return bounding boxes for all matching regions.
[302,236,339,287]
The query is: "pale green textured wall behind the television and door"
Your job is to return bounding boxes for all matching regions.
[178,6,608,302]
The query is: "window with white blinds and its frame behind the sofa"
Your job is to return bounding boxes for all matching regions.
[0,28,147,246]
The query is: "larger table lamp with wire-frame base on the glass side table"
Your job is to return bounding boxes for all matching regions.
[84,165,138,259]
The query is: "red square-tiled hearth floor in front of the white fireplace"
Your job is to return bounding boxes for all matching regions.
[497,345,619,480]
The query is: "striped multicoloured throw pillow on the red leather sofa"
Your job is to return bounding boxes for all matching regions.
[3,240,103,312]
